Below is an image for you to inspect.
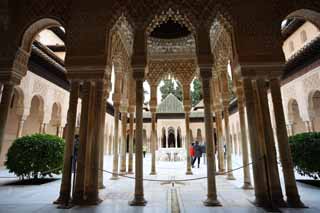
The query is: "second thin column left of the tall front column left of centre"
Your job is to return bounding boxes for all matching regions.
[120,108,127,174]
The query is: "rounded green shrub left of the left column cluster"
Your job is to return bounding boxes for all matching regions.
[5,134,65,179]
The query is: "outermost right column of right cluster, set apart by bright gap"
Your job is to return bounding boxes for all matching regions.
[270,79,305,208]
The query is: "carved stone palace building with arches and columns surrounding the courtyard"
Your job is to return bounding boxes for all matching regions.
[0,0,320,211]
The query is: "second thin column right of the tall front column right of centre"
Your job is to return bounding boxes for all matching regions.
[223,105,235,180]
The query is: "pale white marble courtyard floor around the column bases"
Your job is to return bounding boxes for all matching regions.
[0,155,320,213]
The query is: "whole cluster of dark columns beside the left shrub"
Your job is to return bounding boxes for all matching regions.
[56,77,107,205]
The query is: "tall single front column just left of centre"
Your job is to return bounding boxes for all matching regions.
[130,77,147,206]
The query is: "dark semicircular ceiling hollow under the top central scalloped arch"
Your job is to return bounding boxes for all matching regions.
[150,20,191,39]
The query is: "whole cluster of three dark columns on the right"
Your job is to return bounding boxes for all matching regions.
[238,68,304,207]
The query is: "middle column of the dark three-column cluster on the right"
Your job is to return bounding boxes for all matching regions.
[256,79,286,207]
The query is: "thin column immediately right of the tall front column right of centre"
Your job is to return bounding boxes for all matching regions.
[215,110,225,174]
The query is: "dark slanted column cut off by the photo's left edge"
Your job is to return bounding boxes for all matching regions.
[0,84,14,153]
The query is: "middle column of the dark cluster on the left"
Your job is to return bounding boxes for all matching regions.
[73,81,92,204]
